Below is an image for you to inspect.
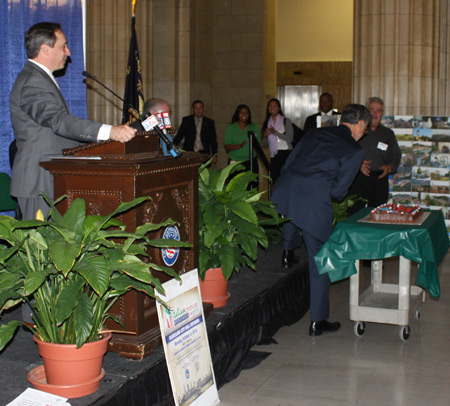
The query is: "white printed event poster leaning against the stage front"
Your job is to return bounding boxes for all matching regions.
[155,269,219,406]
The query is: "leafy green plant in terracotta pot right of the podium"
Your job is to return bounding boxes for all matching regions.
[199,162,284,307]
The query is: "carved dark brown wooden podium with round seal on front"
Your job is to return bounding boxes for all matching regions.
[41,132,208,359]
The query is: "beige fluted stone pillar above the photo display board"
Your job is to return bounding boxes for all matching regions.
[353,0,450,115]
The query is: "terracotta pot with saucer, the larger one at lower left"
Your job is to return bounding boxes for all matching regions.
[28,333,112,397]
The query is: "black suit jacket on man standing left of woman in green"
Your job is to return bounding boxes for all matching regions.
[174,115,217,155]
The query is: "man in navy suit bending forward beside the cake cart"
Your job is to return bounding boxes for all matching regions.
[271,104,371,336]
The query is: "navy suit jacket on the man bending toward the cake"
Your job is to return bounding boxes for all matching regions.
[271,125,364,241]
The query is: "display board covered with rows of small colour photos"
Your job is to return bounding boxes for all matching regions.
[382,116,450,232]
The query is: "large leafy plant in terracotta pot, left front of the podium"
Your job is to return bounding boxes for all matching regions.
[0,196,190,397]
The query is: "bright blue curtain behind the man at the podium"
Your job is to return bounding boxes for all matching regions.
[0,0,86,174]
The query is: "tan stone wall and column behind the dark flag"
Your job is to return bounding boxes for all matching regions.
[86,0,276,164]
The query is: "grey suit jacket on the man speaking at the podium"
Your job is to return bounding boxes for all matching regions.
[9,61,101,198]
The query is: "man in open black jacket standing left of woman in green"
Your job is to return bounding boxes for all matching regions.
[174,100,217,164]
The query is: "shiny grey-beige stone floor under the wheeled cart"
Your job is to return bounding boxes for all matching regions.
[219,253,450,406]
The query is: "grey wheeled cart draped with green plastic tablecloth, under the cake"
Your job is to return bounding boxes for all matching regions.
[315,208,449,340]
